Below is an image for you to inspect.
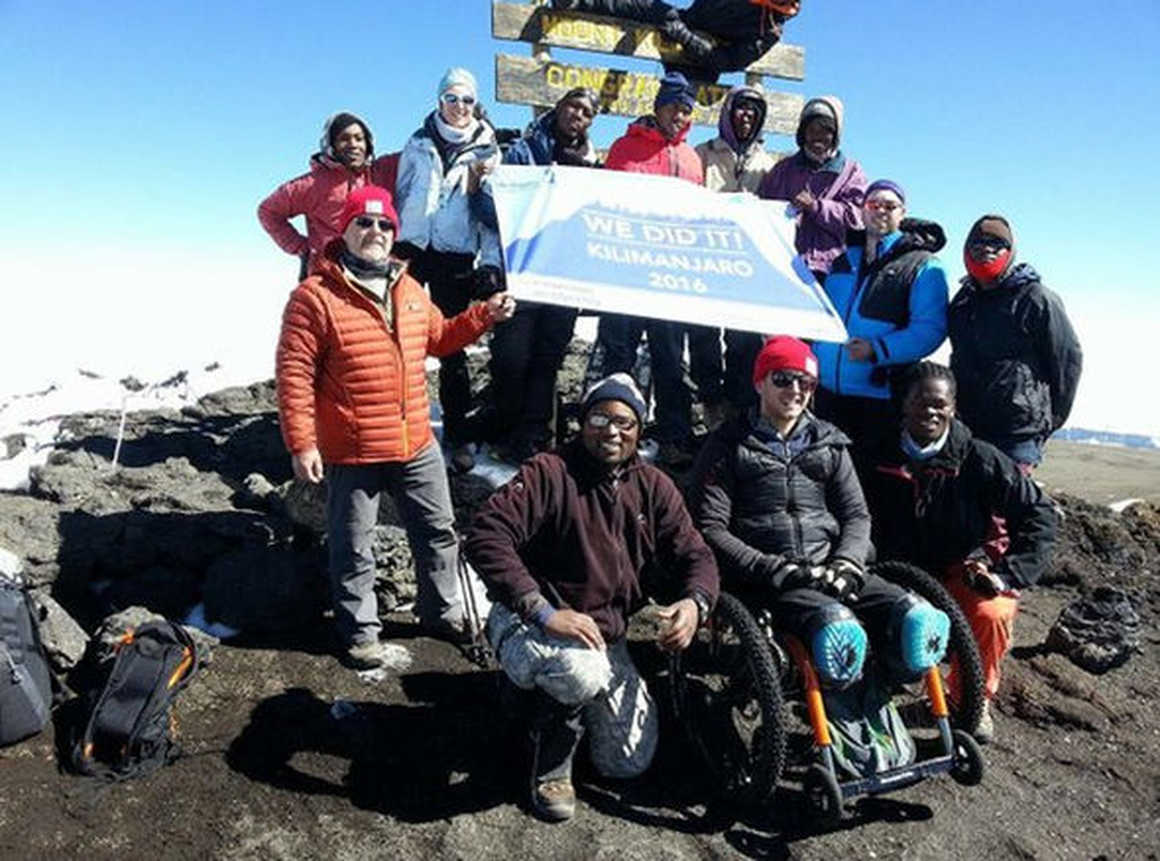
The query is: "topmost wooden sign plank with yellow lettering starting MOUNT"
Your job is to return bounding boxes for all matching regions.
[492,2,805,81]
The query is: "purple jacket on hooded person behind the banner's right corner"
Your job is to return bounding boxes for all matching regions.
[757,151,869,273]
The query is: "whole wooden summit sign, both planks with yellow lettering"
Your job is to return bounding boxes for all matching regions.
[492,2,805,135]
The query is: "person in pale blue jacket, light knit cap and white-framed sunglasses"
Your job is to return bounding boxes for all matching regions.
[396,67,503,472]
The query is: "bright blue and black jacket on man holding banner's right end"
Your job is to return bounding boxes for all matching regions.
[813,218,949,399]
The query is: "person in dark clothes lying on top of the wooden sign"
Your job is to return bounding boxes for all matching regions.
[552,0,802,82]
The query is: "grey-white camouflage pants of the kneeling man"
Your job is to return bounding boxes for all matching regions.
[487,603,659,779]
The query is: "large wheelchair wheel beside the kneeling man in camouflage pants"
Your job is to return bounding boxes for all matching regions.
[670,592,785,804]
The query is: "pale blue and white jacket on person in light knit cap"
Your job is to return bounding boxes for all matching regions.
[396,113,500,266]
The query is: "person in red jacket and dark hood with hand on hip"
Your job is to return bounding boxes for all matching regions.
[258,110,399,281]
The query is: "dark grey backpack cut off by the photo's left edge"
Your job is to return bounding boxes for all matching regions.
[0,577,52,747]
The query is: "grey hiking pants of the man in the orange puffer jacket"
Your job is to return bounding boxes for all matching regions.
[326,442,463,645]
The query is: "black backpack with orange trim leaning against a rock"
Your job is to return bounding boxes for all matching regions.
[73,622,197,780]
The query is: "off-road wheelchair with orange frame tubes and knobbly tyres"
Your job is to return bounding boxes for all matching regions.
[667,562,984,822]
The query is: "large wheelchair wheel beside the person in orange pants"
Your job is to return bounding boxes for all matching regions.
[870,562,985,732]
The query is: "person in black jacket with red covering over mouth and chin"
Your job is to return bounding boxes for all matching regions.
[947,215,1083,471]
